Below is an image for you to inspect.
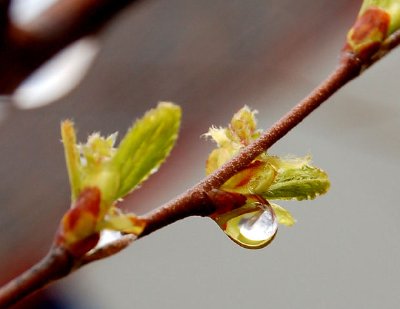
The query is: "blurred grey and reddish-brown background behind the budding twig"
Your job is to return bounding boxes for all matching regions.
[0,0,400,309]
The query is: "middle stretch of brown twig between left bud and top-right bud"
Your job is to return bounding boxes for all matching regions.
[136,55,361,237]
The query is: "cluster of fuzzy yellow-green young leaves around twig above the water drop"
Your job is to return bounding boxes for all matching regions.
[206,106,330,226]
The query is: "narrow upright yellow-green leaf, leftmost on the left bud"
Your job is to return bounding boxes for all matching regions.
[61,120,81,202]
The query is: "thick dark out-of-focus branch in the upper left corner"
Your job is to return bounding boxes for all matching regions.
[0,0,144,94]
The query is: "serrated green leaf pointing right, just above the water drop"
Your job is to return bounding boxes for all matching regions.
[260,160,330,200]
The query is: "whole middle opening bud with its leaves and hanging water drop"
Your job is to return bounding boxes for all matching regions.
[206,107,329,249]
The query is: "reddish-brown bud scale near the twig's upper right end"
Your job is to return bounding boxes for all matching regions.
[344,7,390,61]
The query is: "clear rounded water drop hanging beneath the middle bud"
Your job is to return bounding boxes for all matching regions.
[214,197,278,249]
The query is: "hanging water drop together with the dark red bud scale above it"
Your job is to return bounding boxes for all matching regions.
[209,190,278,249]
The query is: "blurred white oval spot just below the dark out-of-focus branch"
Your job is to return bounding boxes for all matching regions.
[12,38,99,109]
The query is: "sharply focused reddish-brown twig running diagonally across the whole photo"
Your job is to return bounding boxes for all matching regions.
[0,13,400,307]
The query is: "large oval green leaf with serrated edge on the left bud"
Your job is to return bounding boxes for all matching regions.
[111,103,181,199]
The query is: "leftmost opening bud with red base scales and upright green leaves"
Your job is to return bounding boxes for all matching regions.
[56,103,181,256]
